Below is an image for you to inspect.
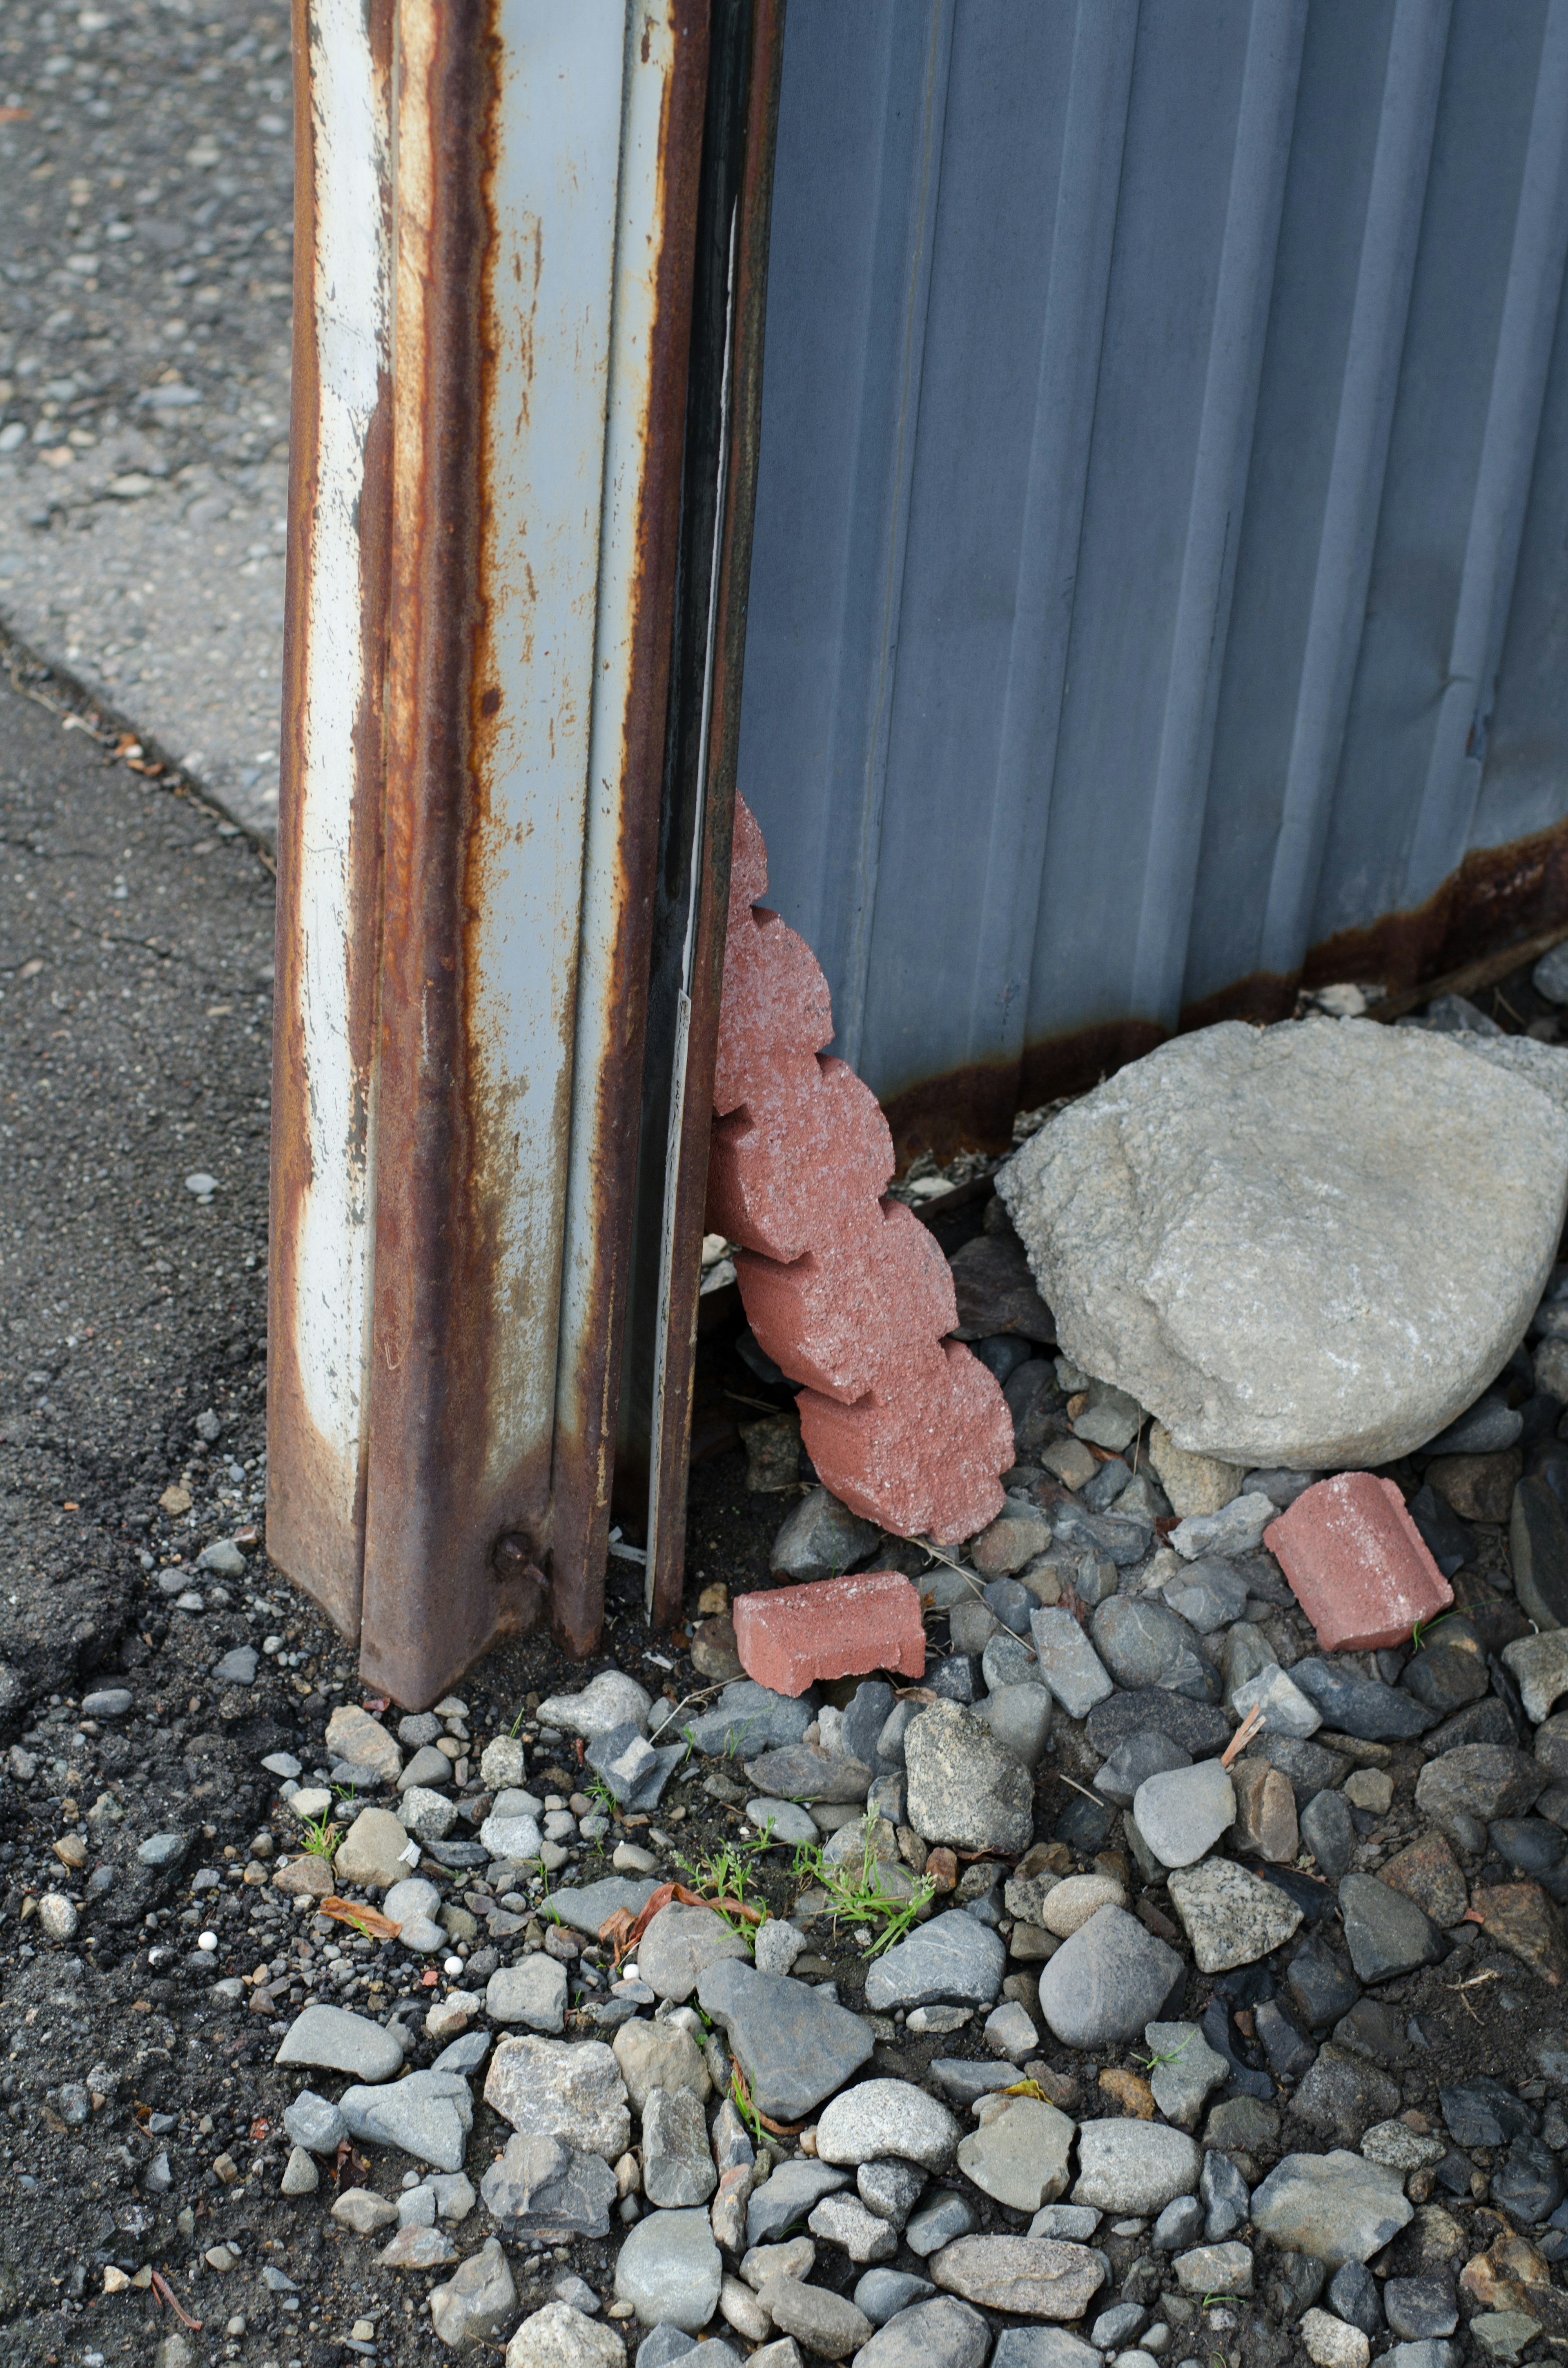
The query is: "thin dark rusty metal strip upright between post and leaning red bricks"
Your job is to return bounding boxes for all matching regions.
[649,0,784,1627]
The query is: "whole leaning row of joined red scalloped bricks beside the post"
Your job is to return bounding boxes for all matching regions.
[708,798,1014,1544]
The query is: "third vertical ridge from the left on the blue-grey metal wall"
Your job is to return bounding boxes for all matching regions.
[1130,0,1307,1028]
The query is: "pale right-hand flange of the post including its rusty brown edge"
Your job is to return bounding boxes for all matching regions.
[550,0,708,1653]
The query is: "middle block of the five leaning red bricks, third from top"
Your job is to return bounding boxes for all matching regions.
[708,1054,893,1264]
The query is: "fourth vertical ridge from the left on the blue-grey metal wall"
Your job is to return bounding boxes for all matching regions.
[1258,0,1452,978]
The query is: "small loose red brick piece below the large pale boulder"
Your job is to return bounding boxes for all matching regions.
[1263,1473,1454,1653]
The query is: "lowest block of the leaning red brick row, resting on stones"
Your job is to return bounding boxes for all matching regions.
[798,1340,1014,1544]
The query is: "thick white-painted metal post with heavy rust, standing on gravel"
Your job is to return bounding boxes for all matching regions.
[270,0,724,1705]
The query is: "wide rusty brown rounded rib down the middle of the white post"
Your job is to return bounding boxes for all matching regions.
[360,0,547,1703]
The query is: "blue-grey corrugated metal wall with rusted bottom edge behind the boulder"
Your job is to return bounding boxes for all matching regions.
[739,0,1568,1142]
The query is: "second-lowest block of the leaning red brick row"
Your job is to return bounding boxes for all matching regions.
[734,1201,959,1404]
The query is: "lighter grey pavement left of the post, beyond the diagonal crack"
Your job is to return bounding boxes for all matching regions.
[0,0,291,831]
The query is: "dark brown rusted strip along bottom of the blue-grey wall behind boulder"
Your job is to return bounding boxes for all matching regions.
[884,822,1568,1170]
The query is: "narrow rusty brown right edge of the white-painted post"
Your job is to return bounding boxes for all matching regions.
[552,0,708,1655]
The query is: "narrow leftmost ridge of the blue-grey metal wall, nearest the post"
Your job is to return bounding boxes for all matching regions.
[829,0,955,1068]
